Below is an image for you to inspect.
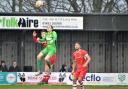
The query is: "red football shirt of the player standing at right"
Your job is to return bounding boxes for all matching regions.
[72,49,88,69]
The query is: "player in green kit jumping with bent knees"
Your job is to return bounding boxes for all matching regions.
[36,25,57,75]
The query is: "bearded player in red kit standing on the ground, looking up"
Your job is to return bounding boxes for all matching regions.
[72,42,91,89]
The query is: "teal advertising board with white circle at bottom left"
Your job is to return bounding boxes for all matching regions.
[0,72,17,84]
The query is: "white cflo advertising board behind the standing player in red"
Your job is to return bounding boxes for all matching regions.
[65,73,128,85]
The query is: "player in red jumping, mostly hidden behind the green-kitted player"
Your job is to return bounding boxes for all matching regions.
[33,31,57,74]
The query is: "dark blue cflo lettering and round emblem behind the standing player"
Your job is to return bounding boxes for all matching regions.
[69,74,101,82]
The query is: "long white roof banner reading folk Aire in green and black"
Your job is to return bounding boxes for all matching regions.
[0,16,83,30]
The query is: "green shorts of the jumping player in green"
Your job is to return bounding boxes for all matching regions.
[41,45,56,57]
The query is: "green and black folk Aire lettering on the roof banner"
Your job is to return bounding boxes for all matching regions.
[0,17,39,28]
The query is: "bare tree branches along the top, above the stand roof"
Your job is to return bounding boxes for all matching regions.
[0,0,128,13]
